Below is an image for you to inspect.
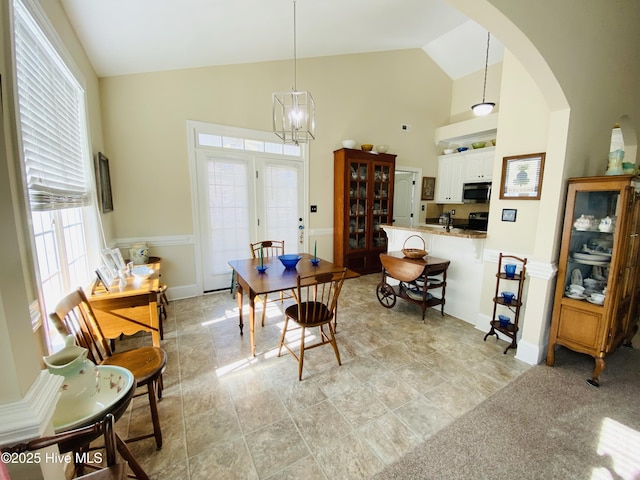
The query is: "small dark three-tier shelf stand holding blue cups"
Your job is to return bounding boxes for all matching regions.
[484,253,527,353]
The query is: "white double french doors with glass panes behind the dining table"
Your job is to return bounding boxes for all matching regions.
[196,149,304,292]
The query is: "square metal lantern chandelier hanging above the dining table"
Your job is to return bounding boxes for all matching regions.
[272,0,316,145]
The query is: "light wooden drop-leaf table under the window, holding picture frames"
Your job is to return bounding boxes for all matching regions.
[87,258,160,347]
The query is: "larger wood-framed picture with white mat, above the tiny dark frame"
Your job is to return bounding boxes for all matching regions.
[500,153,545,200]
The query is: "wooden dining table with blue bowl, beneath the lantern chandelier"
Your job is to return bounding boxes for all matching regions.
[229,253,360,356]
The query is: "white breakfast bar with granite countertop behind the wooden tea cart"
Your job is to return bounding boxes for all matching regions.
[382,224,487,325]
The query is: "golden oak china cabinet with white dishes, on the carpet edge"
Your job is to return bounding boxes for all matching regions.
[547,175,640,386]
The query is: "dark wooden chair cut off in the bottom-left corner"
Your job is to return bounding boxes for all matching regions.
[2,413,127,480]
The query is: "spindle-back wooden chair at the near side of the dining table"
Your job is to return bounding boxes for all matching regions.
[278,268,347,380]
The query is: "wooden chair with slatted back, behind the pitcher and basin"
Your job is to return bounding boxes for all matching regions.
[49,288,167,449]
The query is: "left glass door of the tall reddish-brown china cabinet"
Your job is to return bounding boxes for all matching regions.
[348,161,369,250]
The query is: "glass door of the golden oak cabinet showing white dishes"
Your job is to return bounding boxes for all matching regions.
[565,190,620,304]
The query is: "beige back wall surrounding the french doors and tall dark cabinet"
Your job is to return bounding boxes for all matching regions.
[100,49,452,284]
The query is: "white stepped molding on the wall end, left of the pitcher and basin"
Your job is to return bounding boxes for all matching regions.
[0,370,64,445]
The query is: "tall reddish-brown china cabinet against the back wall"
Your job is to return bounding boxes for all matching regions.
[333,148,396,274]
